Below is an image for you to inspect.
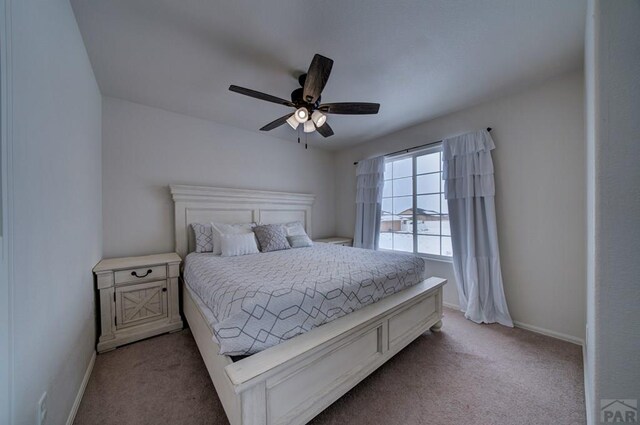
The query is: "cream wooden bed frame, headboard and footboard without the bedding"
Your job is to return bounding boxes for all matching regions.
[170,185,446,425]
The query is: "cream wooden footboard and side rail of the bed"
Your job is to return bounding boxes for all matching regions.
[183,277,446,425]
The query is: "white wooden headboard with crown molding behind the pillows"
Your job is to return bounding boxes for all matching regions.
[169,185,315,258]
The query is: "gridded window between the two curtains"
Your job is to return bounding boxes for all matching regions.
[379,144,453,258]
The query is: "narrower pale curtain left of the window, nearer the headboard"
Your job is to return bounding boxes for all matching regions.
[353,156,384,249]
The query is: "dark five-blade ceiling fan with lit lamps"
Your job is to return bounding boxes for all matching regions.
[229,54,380,137]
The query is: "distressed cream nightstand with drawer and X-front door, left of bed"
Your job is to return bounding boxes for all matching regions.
[93,253,182,353]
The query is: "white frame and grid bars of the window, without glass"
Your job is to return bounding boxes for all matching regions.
[379,142,453,263]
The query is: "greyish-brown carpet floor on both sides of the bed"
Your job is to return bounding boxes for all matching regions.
[75,310,585,425]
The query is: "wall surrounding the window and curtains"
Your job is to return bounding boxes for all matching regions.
[336,69,585,340]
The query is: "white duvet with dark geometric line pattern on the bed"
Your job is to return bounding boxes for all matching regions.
[184,243,426,356]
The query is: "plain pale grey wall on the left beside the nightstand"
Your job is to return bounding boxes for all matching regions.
[7,0,102,425]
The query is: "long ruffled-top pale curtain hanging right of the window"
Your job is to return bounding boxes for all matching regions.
[442,130,513,326]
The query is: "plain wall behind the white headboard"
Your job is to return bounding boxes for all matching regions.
[102,97,335,257]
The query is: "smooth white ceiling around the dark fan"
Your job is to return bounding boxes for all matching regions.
[72,0,586,149]
